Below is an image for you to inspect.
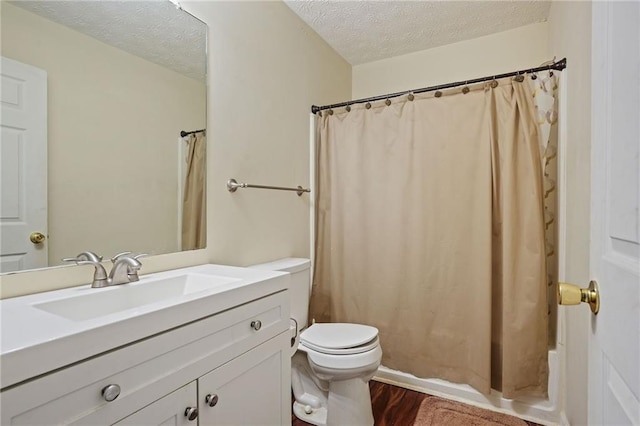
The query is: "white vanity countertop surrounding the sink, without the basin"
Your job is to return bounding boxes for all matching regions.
[0,264,289,389]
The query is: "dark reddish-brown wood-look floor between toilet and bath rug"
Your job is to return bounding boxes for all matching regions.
[291,380,539,426]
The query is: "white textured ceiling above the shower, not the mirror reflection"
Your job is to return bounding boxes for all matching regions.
[285,0,551,65]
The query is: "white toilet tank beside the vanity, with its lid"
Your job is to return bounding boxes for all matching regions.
[249,257,311,331]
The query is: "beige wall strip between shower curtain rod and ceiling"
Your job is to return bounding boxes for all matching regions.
[352,22,551,99]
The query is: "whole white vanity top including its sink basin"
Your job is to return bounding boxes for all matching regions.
[0,264,289,388]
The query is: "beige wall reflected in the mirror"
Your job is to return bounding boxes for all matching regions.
[2,2,206,265]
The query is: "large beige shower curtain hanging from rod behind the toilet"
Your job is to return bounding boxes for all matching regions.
[311,79,548,398]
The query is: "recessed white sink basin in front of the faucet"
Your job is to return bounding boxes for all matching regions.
[32,273,241,321]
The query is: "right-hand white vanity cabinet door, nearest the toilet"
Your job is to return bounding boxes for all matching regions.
[198,333,291,426]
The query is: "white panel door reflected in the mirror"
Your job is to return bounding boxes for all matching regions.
[0,57,47,272]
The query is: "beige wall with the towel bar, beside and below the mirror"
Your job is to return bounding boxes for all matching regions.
[0,2,351,297]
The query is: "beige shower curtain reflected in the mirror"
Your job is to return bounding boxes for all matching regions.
[182,132,207,250]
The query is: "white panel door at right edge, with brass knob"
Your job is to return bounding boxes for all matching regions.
[589,2,640,425]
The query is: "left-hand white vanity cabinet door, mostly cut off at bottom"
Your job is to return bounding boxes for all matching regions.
[115,382,198,426]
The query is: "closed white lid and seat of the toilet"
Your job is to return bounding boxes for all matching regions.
[300,323,378,354]
